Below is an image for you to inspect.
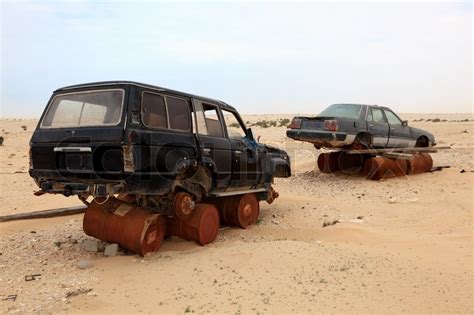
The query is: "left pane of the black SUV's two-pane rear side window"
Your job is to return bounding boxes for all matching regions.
[142,92,168,128]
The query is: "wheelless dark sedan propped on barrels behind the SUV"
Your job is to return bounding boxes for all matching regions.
[286,104,436,149]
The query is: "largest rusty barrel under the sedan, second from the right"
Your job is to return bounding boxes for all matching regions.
[362,156,408,180]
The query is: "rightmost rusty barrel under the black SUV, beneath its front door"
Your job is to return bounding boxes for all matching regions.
[214,194,260,229]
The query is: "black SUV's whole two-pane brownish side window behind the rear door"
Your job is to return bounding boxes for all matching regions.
[142,92,191,131]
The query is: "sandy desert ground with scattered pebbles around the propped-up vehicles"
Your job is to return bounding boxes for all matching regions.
[0,114,474,314]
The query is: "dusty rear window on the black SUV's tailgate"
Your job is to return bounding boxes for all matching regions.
[41,89,124,128]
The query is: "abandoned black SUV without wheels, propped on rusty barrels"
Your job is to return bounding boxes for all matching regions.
[29,81,291,225]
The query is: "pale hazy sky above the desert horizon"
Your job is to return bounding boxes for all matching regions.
[0,1,473,117]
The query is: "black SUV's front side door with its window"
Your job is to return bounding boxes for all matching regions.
[221,108,259,188]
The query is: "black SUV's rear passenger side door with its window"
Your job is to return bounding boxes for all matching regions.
[193,99,232,189]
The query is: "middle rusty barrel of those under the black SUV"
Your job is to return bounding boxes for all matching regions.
[168,203,219,245]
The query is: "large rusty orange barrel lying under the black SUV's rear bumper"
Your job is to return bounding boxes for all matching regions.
[83,197,166,256]
